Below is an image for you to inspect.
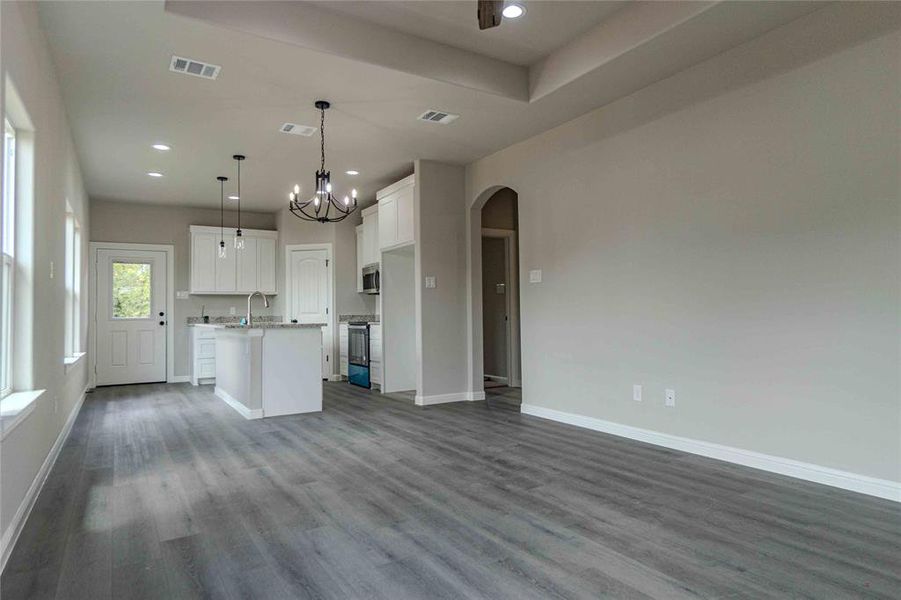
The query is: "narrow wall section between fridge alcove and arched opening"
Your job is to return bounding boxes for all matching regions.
[413,160,467,401]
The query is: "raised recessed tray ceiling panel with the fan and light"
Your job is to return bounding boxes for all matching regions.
[314,0,626,66]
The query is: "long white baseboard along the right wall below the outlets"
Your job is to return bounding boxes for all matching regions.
[520,404,901,502]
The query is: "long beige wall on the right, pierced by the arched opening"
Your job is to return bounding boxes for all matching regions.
[464,3,901,481]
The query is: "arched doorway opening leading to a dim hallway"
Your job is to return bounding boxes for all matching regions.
[471,187,522,405]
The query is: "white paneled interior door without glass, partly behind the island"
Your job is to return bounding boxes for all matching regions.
[288,250,332,379]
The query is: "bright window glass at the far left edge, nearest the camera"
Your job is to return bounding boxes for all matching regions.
[0,119,16,398]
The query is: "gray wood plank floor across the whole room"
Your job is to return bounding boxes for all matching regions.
[0,383,901,600]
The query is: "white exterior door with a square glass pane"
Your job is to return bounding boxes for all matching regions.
[96,249,169,385]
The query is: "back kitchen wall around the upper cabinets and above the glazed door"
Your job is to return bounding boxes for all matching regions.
[91,200,276,376]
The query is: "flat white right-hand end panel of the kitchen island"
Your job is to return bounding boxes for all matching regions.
[261,327,322,417]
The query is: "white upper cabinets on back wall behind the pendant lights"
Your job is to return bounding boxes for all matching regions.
[191,225,278,294]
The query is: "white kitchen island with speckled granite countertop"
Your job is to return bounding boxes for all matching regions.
[197,322,325,419]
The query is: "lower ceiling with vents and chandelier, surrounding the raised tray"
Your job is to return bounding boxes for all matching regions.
[40,0,816,211]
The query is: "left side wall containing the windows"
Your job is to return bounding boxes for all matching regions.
[0,2,91,550]
